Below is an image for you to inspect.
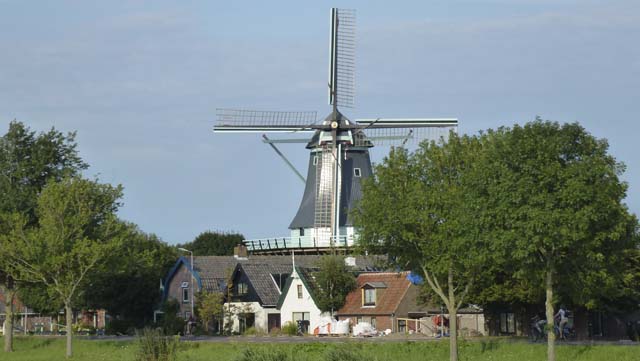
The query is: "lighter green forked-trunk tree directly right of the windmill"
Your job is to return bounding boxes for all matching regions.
[354,133,490,360]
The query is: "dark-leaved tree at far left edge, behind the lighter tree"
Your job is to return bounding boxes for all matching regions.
[0,121,88,352]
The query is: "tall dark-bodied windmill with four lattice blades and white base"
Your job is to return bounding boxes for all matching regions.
[218,8,458,253]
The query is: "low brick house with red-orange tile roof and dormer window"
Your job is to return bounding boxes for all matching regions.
[338,272,484,336]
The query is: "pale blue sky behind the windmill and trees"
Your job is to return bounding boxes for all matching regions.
[0,0,640,243]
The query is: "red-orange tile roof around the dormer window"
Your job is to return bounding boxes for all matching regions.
[338,272,411,316]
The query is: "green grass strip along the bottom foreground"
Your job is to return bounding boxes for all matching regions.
[0,337,640,361]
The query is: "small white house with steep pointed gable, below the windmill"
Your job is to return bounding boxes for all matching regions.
[277,266,330,333]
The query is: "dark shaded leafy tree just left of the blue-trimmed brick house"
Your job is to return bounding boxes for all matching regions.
[79,223,178,327]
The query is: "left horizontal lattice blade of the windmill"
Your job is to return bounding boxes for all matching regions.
[213,108,317,132]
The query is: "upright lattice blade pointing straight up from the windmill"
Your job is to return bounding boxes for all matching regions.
[329,8,356,108]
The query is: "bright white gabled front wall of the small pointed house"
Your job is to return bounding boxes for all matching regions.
[280,271,330,333]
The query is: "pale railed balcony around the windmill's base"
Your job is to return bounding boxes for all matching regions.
[243,236,354,251]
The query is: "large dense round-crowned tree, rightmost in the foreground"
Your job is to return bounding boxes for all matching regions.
[474,119,637,360]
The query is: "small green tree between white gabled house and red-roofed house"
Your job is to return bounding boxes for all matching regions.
[314,255,357,314]
